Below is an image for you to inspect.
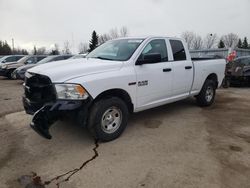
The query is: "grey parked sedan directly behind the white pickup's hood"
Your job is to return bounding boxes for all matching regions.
[13,55,72,80]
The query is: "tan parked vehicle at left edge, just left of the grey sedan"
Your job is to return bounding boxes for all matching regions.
[0,55,46,79]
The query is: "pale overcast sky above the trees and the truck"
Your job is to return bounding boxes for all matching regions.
[0,0,250,53]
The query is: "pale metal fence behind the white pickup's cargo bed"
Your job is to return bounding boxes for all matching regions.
[190,48,250,58]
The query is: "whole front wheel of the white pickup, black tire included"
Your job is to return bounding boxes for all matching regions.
[88,97,129,142]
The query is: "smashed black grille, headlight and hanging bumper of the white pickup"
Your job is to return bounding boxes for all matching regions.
[23,73,90,139]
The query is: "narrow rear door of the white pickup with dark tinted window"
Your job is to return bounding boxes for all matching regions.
[169,39,194,97]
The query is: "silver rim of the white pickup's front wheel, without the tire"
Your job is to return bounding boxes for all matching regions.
[101,107,122,134]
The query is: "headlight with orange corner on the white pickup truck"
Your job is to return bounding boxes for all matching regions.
[55,84,89,100]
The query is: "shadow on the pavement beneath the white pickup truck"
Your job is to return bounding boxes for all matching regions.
[50,98,199,143]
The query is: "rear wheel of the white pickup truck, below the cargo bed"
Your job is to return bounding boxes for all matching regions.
[196,80,216,107]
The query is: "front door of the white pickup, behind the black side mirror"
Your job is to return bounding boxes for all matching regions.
[135,39,172,110]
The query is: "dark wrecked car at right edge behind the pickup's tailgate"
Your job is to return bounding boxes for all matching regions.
[226,56,250,85]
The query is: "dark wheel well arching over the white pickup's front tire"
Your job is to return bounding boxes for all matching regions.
[94,89,134,113]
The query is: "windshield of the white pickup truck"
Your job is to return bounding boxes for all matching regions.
[87,39,143,61]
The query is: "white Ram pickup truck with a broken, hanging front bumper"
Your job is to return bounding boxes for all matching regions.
[23,37,226,141]
